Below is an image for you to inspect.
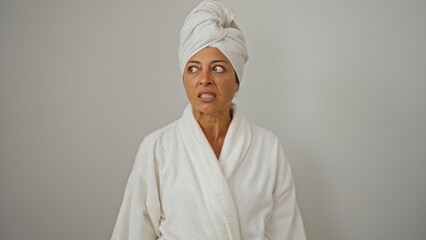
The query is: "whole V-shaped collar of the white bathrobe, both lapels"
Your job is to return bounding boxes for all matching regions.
[181,105,252,240]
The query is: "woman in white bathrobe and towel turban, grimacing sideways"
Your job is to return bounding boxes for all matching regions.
[112,1,306,239]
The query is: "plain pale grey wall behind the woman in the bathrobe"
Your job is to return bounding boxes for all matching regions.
[0,0,426,240]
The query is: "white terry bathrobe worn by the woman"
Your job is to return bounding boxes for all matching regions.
[112,105,306,240]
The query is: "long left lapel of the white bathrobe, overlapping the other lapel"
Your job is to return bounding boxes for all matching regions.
[181,105,241,240]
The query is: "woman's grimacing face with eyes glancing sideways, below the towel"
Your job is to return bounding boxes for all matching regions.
[183,47,239,114]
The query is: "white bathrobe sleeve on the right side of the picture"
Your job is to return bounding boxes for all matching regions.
[266,143,306,240]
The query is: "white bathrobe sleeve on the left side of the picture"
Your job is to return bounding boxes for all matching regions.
[111,136,159,240]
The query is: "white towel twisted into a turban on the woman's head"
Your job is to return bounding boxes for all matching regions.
[179,1,248,81]
